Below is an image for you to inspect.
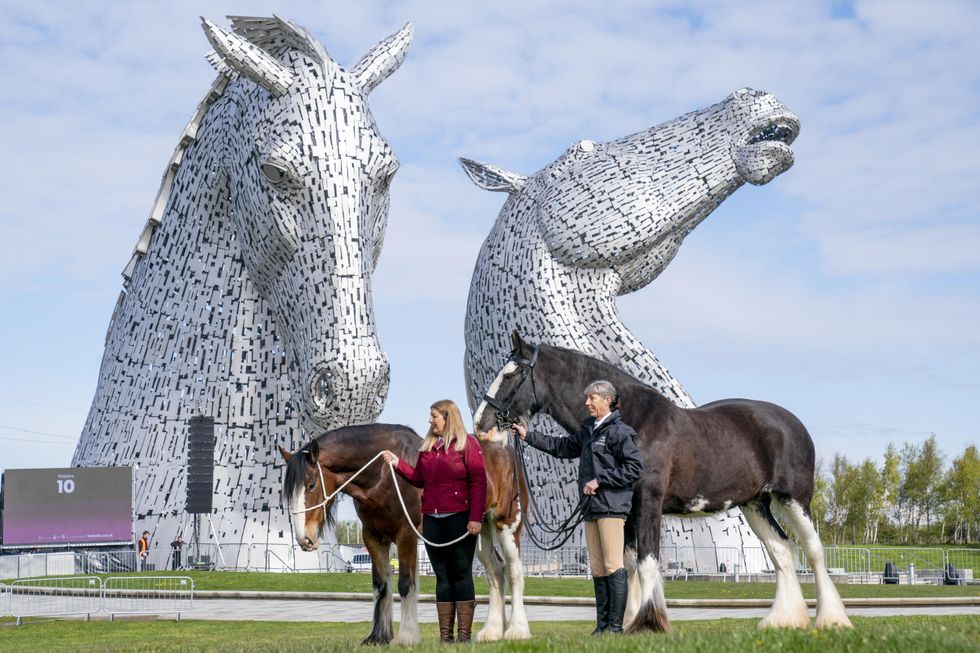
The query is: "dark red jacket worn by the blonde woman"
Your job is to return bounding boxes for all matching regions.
[395,435,487,521]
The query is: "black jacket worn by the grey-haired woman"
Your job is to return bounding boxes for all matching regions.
[526,410,643,519]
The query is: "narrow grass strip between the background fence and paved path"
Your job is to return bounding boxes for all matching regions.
[13,571,980,599]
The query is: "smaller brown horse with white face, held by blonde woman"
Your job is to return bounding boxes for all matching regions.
[280,424,530,644]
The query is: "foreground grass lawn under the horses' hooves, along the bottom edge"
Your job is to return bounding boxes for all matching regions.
[0,617,980,653]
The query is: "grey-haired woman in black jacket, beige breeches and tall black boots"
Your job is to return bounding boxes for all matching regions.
[513,381,643,635]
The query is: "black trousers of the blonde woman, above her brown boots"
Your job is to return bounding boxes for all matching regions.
[422,512,476,601]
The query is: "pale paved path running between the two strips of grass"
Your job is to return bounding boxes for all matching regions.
[181,599,980,623]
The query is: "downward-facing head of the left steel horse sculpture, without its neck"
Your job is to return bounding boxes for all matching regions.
[204,19,411,428]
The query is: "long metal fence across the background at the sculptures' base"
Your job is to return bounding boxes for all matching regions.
[0,544,980,584]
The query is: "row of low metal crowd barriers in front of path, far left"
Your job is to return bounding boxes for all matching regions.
[0,576,194,626]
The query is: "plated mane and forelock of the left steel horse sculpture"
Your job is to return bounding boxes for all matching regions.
[118,16,331,292]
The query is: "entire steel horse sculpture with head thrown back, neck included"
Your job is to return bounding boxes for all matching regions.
[461,89,799,622]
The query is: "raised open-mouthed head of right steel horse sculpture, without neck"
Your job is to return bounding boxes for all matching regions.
[460,89,800,295]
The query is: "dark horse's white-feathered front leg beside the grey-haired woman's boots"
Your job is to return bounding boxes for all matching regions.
[626,484,670,633]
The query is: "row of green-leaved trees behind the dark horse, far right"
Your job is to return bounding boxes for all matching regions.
[810,434,980,545]
